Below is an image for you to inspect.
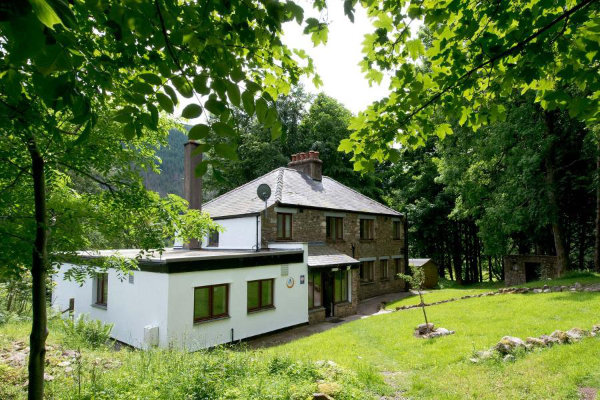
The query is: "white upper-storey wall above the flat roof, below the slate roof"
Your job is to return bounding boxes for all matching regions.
[202,215,261,250]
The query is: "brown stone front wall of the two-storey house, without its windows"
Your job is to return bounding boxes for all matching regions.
[261,206,406,304]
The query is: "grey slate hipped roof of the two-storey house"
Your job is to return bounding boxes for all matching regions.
[202,167,402,218]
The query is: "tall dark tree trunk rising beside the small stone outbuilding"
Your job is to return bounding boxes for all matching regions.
[545,111,569,276]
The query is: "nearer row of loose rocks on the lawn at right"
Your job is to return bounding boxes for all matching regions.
[469,324,600,363]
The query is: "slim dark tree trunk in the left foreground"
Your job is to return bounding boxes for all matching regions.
[27,139,48,400]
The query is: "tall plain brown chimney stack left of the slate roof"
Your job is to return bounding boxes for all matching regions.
[183,141,202,250]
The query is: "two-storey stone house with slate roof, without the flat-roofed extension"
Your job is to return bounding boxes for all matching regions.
[202,151,407,322]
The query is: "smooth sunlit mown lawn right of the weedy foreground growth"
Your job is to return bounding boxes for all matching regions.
[268,275,600,399]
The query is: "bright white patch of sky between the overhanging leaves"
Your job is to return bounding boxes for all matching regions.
[283,0,388,114]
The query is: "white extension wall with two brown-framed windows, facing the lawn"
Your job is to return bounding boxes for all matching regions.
[168,256,308,350]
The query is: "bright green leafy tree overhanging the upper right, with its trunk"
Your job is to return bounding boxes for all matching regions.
[340,0,600,270]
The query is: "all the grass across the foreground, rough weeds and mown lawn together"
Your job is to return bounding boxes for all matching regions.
[0,274,600,399]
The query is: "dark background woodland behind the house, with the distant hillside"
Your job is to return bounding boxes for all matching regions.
[145,87,598,283]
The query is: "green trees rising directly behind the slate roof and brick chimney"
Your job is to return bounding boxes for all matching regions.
[204,87,382,198]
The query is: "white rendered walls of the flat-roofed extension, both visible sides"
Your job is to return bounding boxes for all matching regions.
[52,243,308,350]
